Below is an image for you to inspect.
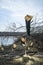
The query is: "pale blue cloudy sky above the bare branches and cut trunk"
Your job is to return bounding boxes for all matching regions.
[0,0,43,31]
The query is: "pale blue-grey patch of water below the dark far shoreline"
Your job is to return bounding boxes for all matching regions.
[0,36,17,46]
